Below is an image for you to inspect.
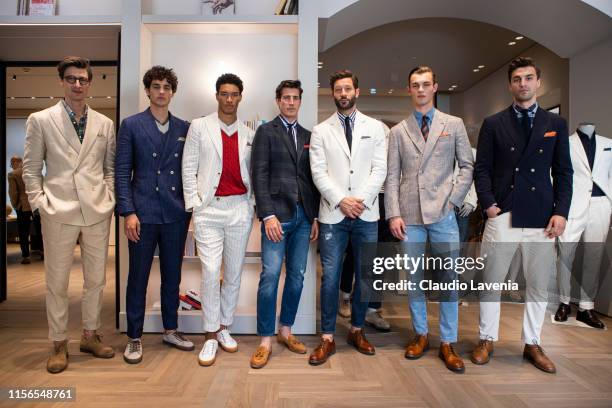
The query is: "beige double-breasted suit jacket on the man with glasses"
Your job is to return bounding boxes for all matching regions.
[23,101,115,226]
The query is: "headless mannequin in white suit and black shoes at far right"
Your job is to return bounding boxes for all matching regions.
[555,124,612,329]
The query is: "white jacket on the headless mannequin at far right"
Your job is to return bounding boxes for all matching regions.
[569,133,612,218]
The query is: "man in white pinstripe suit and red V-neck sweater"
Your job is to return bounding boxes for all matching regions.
[183,74,254,366]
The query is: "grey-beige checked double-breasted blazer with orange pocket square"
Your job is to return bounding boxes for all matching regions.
[385,109,474,225]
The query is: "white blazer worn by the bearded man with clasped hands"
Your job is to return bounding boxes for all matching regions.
[310,111,389,224]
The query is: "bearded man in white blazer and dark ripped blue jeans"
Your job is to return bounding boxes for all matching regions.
[309,70,388,365]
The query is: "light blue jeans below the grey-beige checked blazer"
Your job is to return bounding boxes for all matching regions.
[402,211,459,343]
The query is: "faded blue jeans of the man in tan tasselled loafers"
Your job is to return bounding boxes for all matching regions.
[257,205,311,336]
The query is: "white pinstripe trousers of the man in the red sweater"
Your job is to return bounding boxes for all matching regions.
[193,194,253,332]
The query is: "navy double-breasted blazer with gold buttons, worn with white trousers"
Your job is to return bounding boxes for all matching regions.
[474,106,574,228]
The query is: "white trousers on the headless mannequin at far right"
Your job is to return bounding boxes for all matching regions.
[557,196,612,310]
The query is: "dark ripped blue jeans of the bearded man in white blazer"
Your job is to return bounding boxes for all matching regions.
[319,218,378,334]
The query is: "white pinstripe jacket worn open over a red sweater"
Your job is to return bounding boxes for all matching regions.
[183,112,255,211]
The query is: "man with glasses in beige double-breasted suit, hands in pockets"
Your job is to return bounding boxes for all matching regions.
[23,57,115,373]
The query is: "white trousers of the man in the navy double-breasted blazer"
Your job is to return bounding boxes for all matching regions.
[480,213,555,344]
